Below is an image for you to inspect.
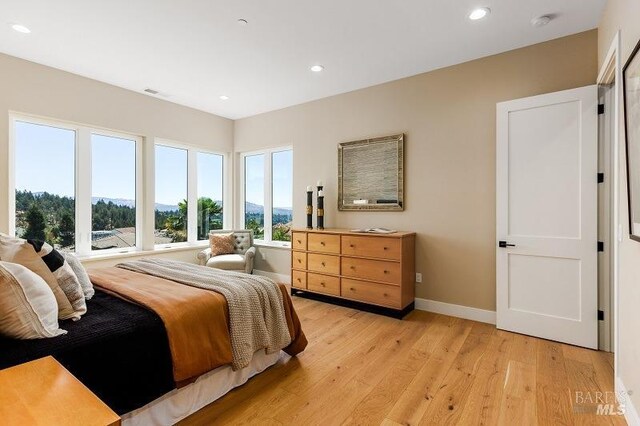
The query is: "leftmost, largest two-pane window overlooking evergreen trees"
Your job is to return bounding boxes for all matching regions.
[9,117,141,255]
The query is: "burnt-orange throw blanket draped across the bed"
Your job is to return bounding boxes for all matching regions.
[89,267,307,386]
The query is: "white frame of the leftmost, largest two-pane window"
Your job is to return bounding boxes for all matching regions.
[7,112,144,257]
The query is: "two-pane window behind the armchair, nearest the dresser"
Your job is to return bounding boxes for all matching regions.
[242,149,293,245]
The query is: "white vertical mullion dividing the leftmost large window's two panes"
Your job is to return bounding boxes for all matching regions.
[75,127,92,255]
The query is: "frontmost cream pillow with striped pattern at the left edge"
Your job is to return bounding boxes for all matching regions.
[0,261,67,339]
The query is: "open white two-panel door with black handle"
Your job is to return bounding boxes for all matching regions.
[496,86,598,349]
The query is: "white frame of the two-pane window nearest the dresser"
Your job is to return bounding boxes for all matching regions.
[239,145,294,248]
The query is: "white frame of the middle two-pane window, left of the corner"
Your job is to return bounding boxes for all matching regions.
[150,138,232,250]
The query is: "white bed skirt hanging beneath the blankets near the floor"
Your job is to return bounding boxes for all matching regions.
[122,349,289,426]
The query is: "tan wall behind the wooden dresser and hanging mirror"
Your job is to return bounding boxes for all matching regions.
[234,30,597,310]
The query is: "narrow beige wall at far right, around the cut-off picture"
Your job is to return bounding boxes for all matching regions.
[598,0,640,410]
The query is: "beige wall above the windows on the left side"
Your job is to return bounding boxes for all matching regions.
[0,54,233,264]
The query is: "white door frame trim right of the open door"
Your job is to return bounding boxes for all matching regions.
[597,30,622,382]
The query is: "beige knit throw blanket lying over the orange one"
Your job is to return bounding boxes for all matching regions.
[116,259,291,370]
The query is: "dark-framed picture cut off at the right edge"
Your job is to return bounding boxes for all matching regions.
[622,40,640,242]
